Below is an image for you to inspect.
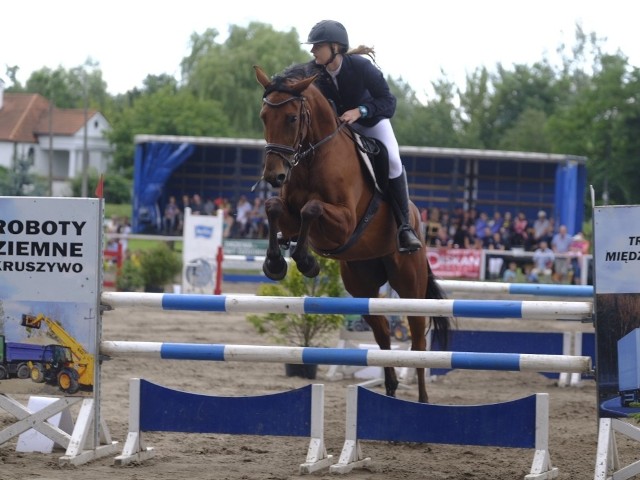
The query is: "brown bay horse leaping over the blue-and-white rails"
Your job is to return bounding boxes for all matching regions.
[254,65,450,402]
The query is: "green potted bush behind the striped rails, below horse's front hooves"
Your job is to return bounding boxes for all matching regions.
[247,256,345,378]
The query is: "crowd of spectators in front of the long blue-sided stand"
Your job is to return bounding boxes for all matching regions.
[162,193,590,283]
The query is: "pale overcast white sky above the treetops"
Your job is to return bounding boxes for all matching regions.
[0,0,640,98]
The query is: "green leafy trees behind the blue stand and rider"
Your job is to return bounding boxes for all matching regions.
[7,22,640,204]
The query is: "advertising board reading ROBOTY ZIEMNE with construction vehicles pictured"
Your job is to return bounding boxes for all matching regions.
[0,197,102,395]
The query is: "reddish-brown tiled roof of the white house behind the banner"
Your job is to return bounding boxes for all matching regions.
[0,92,96,143]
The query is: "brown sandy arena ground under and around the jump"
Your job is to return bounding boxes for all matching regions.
[0,285,637,480]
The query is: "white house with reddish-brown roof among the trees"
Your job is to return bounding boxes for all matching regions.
[0,80,112,196]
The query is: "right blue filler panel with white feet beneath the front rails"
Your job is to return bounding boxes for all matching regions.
[331,386,557,479]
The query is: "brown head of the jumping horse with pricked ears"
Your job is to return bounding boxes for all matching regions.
[253,66,319,187]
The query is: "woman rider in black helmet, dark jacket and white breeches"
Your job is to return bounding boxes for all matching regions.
[306,20,422,253]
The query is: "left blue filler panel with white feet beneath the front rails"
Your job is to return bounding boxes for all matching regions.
[115,378,335,473]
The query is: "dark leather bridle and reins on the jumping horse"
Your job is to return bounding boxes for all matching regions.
[262,88,345,175]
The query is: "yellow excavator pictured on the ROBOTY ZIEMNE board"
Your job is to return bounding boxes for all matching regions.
[21,313,94,394]
